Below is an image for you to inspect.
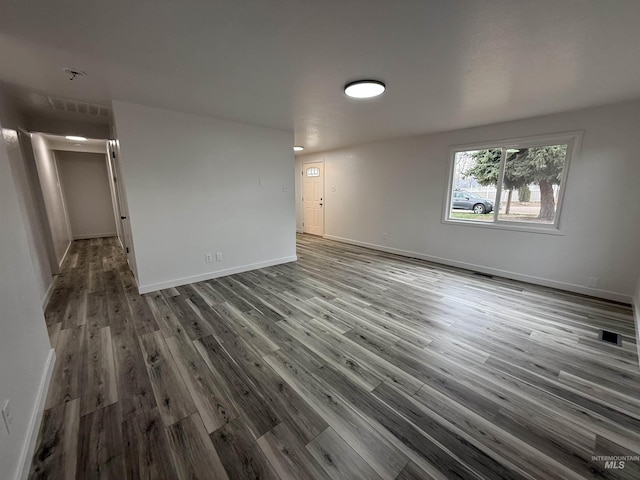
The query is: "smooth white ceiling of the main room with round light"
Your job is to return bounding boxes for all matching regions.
[0,0,640,152]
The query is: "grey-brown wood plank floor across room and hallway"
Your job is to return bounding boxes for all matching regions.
[30,236,640,480]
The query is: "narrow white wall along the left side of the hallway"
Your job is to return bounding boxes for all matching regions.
[31,133,71,265]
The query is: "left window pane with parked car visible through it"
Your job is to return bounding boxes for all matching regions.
[449,148,502,222]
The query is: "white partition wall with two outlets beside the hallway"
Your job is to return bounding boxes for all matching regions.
[113,102,295,292]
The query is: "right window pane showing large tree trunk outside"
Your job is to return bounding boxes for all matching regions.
[498,145,567,224]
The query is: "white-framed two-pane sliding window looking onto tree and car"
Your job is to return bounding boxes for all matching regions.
[444,132,580,230]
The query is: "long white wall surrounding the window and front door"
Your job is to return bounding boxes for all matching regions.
[296,101,640,302]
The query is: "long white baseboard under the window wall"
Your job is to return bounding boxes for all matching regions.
[324,235,632,304]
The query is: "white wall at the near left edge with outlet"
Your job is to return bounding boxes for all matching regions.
[0,118,53,479]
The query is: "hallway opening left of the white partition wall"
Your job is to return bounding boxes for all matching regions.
[28,132,135,284]
